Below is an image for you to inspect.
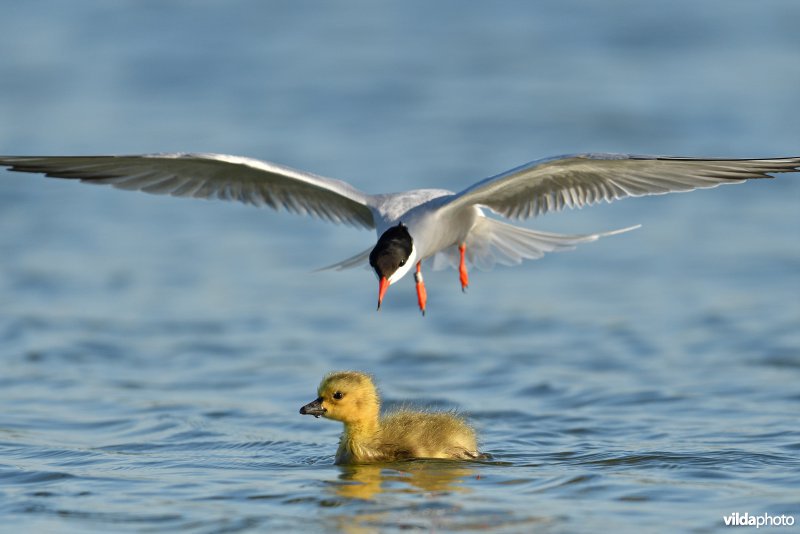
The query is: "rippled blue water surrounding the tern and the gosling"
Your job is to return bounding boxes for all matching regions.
[0,0,800,532]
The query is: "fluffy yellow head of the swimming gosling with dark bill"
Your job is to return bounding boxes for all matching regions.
[300,371,380,424]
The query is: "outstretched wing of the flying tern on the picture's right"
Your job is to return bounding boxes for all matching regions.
[442,154,800,219]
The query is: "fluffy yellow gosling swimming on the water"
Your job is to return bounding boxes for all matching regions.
[300,371,482,464]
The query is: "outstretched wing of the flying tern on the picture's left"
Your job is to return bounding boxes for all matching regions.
[0,153,375,228]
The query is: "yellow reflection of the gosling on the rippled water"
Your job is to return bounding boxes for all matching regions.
[330,460,474,500]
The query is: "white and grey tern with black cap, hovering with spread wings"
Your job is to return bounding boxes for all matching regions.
[0,153,800,315]
